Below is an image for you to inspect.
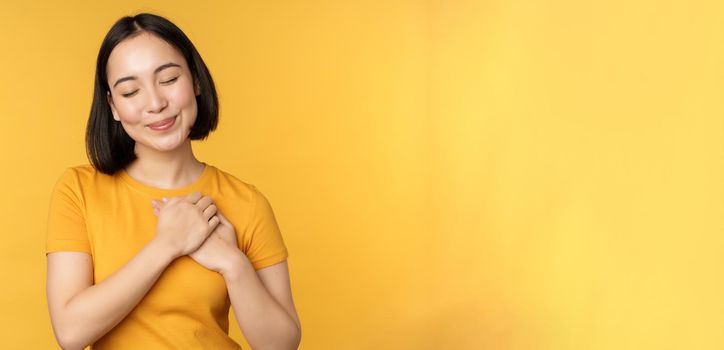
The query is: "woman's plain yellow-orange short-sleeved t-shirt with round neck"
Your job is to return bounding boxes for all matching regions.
[46,163,288,349]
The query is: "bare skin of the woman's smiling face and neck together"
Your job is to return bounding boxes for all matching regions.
[106,33,203,188]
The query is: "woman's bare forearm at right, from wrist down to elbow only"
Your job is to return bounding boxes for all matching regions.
[224,254,301,350]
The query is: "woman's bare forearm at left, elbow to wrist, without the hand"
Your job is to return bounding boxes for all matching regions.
[58,240,174,349]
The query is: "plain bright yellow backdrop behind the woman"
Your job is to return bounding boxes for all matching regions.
[0,0,724,350]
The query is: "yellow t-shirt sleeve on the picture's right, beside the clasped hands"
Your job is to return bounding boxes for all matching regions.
[244,186,289,270]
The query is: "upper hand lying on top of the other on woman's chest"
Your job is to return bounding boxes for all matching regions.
[152,192,220,257]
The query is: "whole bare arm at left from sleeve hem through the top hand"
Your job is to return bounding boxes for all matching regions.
[46,192,219,349]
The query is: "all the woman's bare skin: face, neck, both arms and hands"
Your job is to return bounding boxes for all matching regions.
[46,33,301,349]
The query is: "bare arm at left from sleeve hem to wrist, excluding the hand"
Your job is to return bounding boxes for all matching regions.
[47,240,174,349]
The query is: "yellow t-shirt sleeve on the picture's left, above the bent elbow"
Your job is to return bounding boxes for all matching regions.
[45,168,91,255]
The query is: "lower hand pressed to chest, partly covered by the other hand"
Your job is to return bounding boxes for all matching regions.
[153,201,243,275]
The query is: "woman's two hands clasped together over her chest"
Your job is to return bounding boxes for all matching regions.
[151,192,243,275]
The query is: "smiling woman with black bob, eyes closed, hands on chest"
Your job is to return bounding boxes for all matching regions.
[46,14,301,349]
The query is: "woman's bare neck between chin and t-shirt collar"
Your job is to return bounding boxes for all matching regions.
[126,138,204,189]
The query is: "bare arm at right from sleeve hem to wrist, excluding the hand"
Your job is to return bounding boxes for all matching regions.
[222,252,302,350]
